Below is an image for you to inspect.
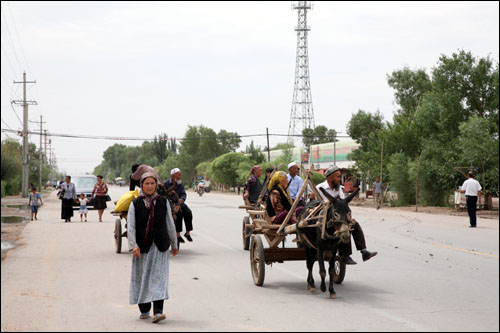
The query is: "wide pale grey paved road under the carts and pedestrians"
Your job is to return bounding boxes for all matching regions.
[1,187,499,331]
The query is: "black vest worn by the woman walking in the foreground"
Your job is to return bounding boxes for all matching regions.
[133,196,170,253]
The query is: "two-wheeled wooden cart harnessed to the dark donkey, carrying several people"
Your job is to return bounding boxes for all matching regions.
[239,166,346,286]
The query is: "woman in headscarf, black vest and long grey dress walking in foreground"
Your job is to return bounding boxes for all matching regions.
[127,172,179,323]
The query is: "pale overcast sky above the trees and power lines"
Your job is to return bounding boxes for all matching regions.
[1,1,499,174]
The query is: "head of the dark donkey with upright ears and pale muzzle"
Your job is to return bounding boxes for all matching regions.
[320,188,359,243]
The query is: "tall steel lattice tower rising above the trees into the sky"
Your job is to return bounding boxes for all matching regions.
[288,1,315,143]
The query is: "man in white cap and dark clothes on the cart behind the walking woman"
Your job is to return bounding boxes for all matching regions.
[164,168,193,243]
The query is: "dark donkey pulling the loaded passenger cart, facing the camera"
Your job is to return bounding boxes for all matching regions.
[298,188,359,298]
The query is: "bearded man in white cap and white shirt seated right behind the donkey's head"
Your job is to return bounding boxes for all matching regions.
[316,166,377,265]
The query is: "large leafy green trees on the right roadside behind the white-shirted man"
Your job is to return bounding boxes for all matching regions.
[347,50,499,205]
